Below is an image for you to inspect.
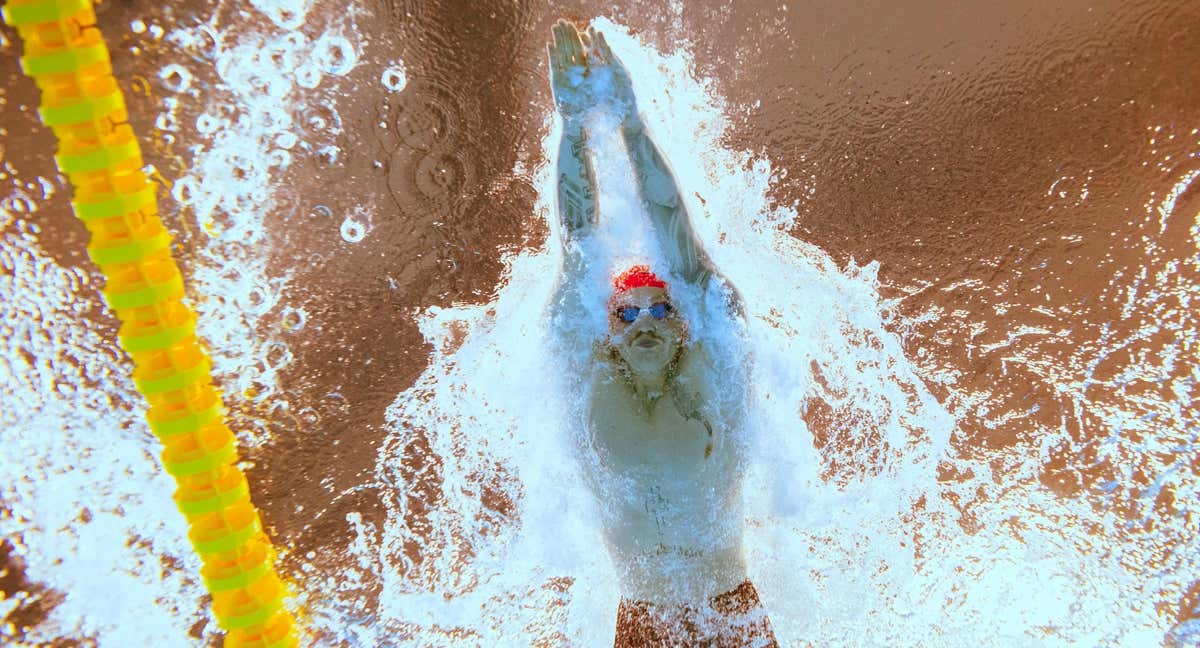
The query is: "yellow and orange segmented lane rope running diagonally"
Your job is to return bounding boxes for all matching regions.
[4,0,299,648]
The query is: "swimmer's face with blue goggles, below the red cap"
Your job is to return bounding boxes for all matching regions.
[608,286,685,373]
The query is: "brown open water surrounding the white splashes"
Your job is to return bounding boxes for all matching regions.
[0,0,1200,644]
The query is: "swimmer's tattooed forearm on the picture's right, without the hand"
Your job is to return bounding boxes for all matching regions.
[622,115,713,284]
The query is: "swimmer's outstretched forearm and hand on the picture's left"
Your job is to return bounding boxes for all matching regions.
[547,22,596,240]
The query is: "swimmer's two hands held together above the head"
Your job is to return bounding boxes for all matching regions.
[546,20,637,122]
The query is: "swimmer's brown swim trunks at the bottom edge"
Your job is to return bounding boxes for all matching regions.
[613,581,779,648]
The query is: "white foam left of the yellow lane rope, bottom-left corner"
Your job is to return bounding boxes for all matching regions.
[0,221,208,646]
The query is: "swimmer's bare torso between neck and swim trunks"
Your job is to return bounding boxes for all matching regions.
[588,347,745,604]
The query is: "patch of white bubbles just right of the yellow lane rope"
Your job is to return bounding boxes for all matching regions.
[161,0,371,445]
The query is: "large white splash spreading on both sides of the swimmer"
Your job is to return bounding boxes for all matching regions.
[316,19,1183,646]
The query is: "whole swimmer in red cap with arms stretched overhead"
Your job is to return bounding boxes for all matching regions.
[548,22,776,647]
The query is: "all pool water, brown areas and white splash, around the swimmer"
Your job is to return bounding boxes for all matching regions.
[0,0,1200,647]
